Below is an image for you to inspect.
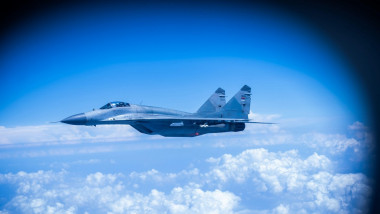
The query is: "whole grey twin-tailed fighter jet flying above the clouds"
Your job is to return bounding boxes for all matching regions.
[60,85,271,137]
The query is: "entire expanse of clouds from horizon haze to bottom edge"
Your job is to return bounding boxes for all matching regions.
[0,120,372,213]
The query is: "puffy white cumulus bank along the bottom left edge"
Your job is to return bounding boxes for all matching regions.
[0,171,240,213]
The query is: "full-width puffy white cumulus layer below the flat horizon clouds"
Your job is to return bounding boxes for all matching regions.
[0,148,371,213]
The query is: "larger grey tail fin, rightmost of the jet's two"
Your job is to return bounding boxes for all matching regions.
[222,85,251,119]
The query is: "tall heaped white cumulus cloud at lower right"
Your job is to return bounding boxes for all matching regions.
[206,149,371,213]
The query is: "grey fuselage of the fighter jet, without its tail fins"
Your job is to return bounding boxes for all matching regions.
[62,104,245,137]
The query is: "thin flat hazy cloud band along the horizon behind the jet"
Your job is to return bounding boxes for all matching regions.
[0,119,373,157]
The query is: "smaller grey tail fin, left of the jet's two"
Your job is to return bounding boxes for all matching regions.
[197,88,226,114]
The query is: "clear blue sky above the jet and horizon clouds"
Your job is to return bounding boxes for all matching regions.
[0,2,366,126]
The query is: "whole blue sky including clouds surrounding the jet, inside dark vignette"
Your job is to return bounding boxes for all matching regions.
[0,2,371,213]
